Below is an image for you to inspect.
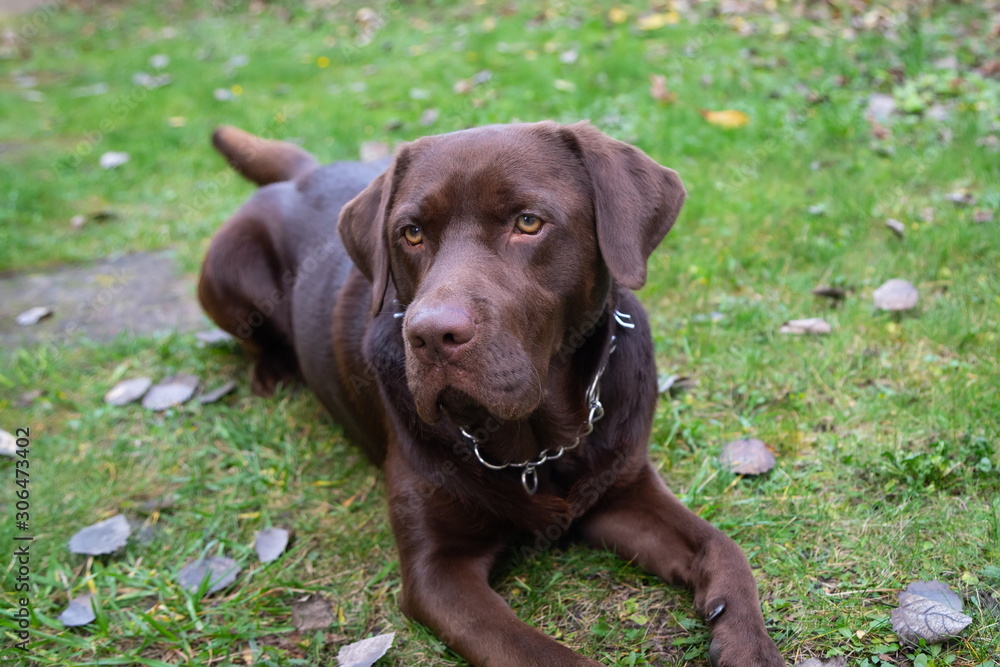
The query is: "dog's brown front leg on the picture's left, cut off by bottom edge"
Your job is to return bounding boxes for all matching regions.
[385,456,601,667]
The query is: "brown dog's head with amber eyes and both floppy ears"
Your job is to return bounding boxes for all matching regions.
[339,122,685,423]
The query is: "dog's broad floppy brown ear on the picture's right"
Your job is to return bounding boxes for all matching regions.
[564,122,687,289]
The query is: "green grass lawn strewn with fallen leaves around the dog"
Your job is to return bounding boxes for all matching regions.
[0,2,1000,667]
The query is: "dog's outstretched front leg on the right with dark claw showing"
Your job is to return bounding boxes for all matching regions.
[581,465,785,667]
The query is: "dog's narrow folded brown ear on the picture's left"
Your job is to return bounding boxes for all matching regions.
[337,147,406,317]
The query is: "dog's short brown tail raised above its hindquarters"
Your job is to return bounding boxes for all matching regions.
[212,125,318,185]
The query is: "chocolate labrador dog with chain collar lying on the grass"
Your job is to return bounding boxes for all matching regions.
[198,122,784,667]
